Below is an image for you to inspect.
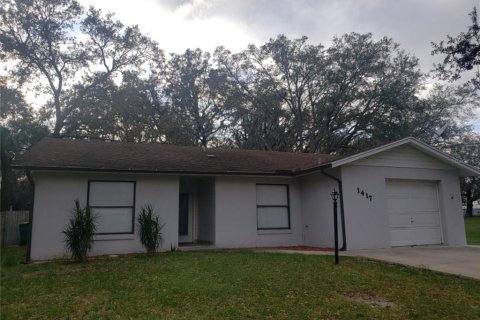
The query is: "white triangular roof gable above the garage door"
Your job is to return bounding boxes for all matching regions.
[331,137,480,176]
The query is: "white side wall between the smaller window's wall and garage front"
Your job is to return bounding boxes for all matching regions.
[300,170,343,248]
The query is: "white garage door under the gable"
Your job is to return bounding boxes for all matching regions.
[387,180,442,247]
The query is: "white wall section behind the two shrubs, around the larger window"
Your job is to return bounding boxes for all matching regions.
[31,172,179,260]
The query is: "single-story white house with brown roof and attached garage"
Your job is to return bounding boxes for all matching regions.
[14,138,480,260]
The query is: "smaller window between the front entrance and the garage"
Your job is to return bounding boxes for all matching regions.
[257,184,290,230]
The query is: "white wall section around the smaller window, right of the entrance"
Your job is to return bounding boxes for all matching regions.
[215,177,303,248]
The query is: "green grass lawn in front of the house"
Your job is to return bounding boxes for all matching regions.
[0,249,480,319]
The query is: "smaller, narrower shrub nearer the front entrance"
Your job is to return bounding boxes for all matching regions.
[138,205,164,254]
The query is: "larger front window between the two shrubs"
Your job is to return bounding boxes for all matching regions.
[88,181,135,234]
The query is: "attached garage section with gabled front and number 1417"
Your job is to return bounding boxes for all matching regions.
[326,138,480,250]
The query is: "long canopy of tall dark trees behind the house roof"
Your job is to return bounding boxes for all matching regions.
[0,0,478,153]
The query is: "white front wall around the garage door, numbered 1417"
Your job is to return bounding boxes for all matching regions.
[342,162,466,250]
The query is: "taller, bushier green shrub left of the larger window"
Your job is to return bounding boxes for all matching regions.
[63,200,97,262]
